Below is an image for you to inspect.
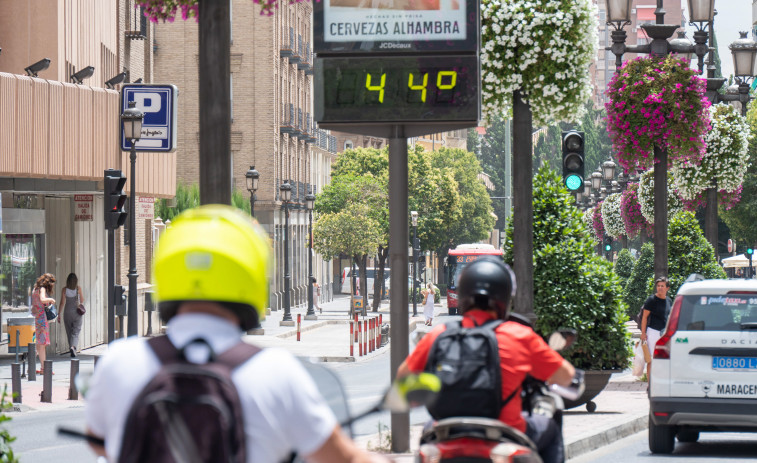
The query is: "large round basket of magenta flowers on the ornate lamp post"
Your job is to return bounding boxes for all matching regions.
[605,56,710,172]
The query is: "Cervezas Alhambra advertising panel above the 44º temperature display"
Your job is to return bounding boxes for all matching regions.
[313,0,480,56]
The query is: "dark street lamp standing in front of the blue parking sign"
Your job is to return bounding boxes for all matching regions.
[121,101,144,336]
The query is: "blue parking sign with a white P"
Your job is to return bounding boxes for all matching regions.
[119,84,179,153]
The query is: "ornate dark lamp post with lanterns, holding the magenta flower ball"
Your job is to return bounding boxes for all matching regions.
[606,0,715,277]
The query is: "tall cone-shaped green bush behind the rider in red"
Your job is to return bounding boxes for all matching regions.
[505,168,631,370]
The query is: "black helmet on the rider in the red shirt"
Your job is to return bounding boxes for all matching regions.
[457,256,516,320]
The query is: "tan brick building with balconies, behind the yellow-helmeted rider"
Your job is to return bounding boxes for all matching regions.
[154,0,337,310]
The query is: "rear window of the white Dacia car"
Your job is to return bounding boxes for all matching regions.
[678,294,757,331]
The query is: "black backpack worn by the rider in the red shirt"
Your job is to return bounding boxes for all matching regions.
[426,320,520,420]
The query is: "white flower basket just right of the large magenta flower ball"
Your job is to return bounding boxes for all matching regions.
[671,103,750,210]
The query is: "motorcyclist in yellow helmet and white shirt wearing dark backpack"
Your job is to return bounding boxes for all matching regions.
[86,205,385,463]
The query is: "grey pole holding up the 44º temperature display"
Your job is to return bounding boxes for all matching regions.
[389,125,410,453]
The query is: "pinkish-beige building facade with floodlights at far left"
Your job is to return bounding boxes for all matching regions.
[0,0,175,352]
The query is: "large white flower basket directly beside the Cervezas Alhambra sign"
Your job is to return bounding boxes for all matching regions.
[481,0,598,126]
